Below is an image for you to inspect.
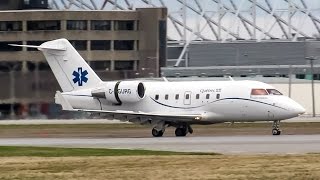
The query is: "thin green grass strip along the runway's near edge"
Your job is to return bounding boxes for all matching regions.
[0,146,218,157]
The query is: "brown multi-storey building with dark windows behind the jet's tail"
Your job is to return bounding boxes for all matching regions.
[0,1,167,118]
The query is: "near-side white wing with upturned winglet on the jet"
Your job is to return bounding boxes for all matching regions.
[55,91,202,122]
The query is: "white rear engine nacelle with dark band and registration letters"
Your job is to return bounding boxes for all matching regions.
[91,81,145,105]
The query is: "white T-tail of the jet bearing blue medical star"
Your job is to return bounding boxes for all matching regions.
[10,39,102,92]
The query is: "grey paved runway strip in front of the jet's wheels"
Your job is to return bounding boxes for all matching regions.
[0,135,320,154]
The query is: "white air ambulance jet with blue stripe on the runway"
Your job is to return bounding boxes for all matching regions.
[12,39,305,137]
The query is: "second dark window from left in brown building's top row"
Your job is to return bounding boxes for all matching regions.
[27,21,60,31]
